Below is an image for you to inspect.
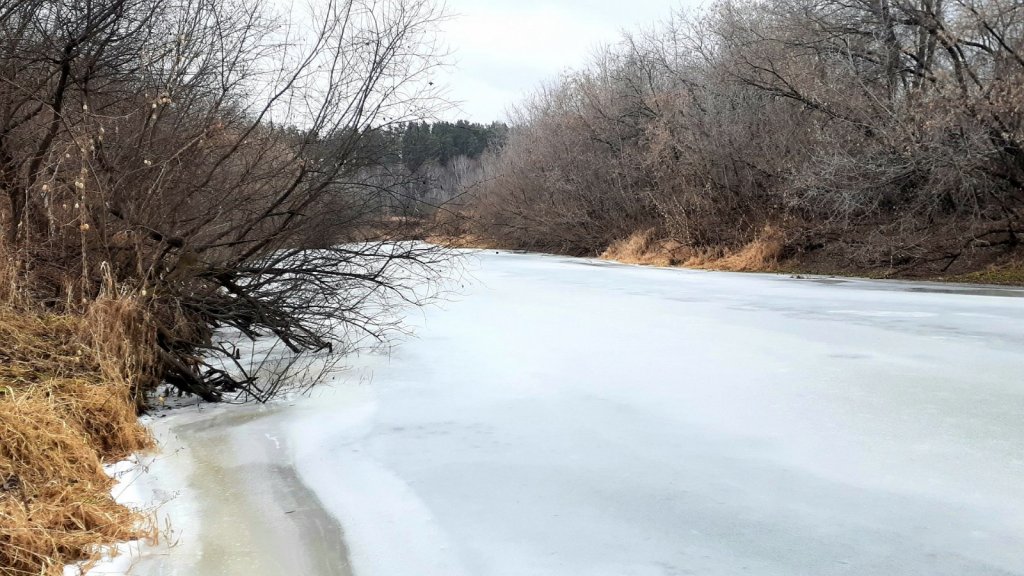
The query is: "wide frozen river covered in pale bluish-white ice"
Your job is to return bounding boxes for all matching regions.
[123,252,1024,576]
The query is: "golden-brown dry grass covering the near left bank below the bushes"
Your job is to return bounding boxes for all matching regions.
[0,286,153,576]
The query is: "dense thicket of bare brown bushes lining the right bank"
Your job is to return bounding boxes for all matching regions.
[465,0,1024,274]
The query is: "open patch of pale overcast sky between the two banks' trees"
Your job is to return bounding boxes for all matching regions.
[440,0,678,122]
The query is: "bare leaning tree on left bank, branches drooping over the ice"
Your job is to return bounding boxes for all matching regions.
[0,0,452,400]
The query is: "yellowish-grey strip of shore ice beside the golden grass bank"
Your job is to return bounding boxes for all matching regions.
[96,401,350,576]
